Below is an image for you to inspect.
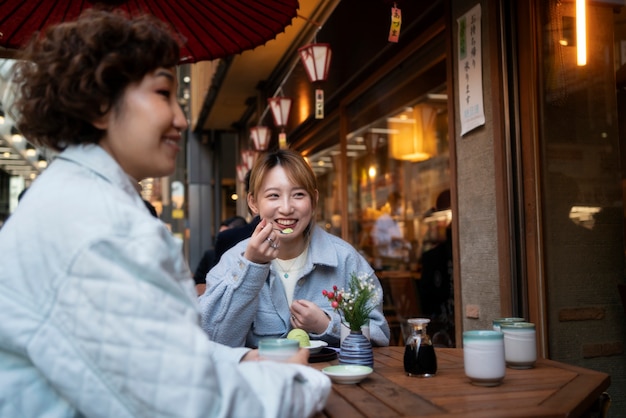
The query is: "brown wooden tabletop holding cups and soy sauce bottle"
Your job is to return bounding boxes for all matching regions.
[312,347,610,418]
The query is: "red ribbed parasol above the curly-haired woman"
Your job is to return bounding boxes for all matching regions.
[0,0,298,64]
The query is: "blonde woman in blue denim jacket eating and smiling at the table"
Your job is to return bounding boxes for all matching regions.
[200,150,389,347]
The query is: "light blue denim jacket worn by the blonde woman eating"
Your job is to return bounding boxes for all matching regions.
[200,226,389,347]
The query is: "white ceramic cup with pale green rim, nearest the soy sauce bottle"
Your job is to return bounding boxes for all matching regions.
[463,330,506,386]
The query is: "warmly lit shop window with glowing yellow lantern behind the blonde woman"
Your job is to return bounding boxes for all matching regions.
[309,87,452,272]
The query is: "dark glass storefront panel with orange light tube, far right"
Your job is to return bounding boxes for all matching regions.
[521,0,626,416]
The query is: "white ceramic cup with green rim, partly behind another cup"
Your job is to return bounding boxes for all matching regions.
[500,322,537,369]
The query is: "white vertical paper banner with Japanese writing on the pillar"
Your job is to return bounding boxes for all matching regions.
[457,4,485,135]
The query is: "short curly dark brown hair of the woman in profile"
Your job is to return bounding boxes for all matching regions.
[13,9,180,151]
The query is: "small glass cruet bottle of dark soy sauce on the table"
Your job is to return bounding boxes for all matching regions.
[404,318,437,377]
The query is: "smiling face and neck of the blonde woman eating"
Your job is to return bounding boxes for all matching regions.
[248,165,317,255]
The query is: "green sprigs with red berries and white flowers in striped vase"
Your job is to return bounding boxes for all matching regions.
[322,273,380,331]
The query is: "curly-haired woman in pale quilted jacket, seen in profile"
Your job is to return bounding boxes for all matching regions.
[0,8,330,418]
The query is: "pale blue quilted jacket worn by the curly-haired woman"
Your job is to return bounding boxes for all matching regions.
[0,145,330,418]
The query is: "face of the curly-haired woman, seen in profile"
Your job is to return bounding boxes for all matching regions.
[93,68,187,181]
